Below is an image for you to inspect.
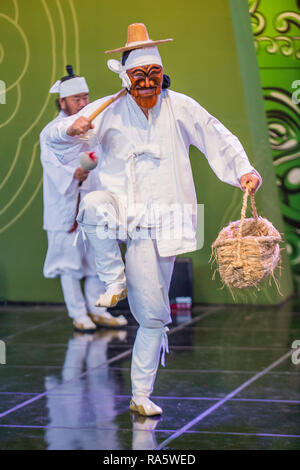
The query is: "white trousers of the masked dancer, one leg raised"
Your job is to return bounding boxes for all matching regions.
[77,191,175,397]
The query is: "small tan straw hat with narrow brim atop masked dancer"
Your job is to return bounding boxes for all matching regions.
[105,23,173,54]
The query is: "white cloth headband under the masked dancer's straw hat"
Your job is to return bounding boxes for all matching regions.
[107,46,162,89]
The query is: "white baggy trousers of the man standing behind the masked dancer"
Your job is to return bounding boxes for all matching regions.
[44,231,106,319]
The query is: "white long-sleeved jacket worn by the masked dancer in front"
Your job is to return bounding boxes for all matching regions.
[47,90,261,256]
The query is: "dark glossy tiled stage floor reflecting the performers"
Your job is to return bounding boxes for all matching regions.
[0,299,300,450]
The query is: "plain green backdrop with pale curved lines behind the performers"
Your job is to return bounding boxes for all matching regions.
[0,0,292,304]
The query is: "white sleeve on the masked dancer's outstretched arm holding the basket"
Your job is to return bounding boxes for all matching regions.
[182,95,262,188]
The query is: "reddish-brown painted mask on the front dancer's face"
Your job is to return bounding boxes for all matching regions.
[126,64,163,109]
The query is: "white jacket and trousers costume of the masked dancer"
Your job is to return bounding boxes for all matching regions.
[47,90,262,397]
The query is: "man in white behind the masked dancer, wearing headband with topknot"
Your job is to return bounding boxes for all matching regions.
[40,65,127,331]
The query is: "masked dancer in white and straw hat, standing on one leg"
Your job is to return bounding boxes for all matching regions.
[45,24,262,416]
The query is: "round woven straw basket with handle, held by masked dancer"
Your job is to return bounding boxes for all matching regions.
[212,186,282,289]
